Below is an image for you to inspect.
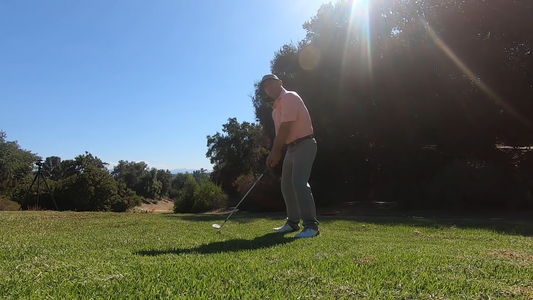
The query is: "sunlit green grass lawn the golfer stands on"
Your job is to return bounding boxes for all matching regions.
[0,212,533,299]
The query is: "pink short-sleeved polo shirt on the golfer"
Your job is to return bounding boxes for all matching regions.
[272,88,313,144]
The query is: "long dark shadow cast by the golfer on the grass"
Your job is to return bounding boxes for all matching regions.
[135,232,294,256]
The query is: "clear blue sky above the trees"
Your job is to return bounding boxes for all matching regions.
[0,0,329,170]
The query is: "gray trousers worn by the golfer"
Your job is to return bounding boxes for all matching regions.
[281,139,318,230]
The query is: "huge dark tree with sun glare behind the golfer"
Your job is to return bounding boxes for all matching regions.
[252,0,533,209]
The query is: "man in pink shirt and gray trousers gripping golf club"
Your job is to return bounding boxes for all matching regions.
[260,74,320,238]
